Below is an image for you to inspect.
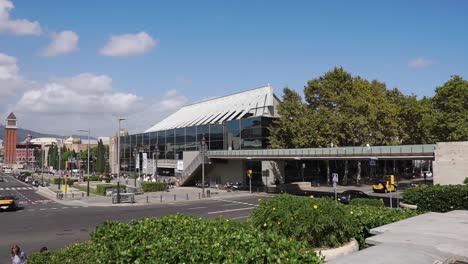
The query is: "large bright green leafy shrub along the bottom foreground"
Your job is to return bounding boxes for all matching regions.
[91,215,321,263]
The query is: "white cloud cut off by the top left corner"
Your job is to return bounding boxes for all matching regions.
[0,0,42,35]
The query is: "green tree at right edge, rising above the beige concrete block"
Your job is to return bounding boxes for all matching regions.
[432,75,468,141]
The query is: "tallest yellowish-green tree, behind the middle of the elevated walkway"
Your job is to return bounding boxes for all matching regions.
[304,68,399,146]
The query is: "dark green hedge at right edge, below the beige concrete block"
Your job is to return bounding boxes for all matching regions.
[403,185,468,212]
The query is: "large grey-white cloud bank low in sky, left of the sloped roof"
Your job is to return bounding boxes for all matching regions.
[16,73,141,114]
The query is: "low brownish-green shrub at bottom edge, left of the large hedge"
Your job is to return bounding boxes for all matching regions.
[28,242,99,264]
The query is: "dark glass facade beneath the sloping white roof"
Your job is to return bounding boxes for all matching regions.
[120,117,273,172]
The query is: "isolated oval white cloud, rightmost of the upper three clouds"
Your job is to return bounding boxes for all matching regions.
[100,32,158,57]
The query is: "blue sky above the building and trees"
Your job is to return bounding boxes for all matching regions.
[0,0,468,136]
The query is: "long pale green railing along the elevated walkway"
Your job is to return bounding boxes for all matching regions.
[208,144,435,158]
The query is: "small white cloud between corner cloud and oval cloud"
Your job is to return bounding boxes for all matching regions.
[41,30,79,57]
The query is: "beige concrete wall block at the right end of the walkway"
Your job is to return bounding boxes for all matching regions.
[433,141,468,185]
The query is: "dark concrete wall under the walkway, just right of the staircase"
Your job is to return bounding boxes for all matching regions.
[207,160,246,184]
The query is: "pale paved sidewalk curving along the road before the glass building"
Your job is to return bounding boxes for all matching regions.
[38,185,269,207]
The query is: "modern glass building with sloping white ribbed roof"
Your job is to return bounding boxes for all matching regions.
[120,85,279,175]
